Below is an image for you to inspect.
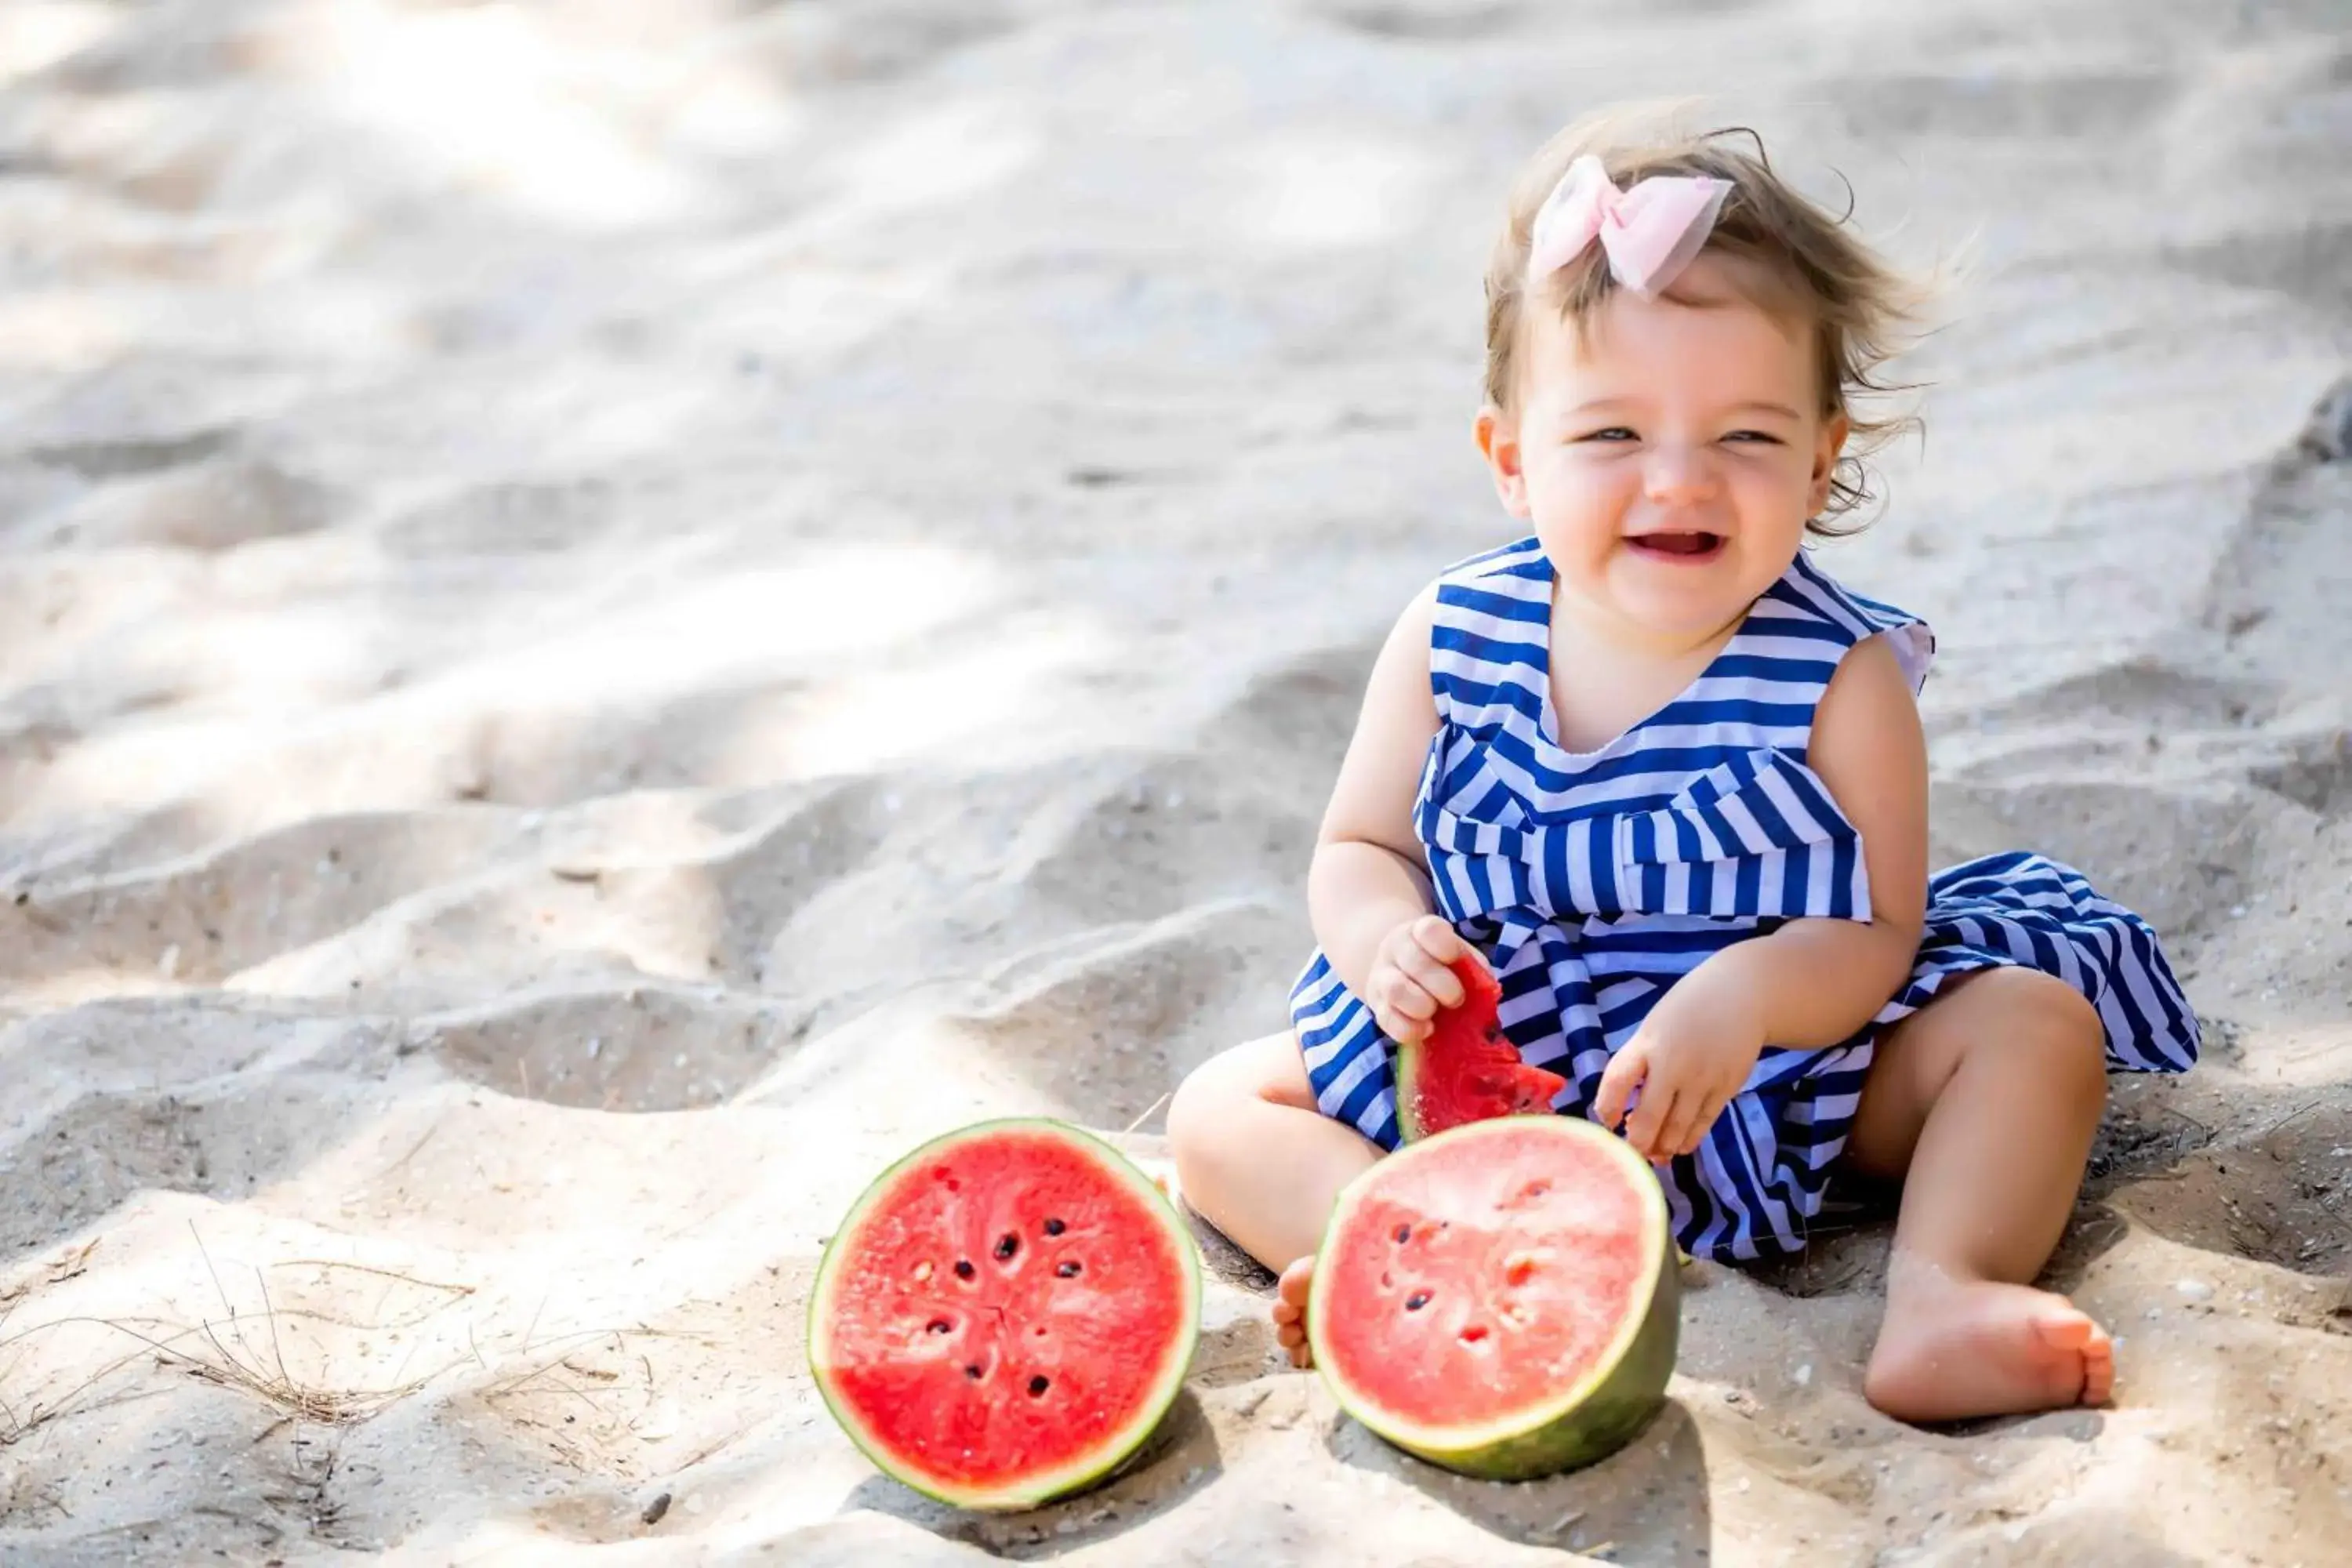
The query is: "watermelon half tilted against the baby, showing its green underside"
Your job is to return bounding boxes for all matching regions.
[1308,1116,1679,1481]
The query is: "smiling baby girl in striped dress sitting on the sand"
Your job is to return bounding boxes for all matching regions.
[1169,122,2197,1420]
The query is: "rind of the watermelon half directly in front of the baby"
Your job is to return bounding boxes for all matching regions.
[1308,1116,1682,1481]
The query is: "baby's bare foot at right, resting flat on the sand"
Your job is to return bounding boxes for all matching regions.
[1863,1265,2114,1422]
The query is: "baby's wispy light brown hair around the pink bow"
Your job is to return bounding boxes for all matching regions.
[1486,111,1926,536]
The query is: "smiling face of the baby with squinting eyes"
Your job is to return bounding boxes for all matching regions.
[1479,256,1846,647]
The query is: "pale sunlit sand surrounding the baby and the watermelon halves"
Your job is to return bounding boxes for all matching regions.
[0,0,2352,1568]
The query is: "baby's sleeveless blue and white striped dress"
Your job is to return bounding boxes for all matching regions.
[1291,539,2197,1258]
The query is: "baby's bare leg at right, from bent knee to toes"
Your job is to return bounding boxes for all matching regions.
[1846,968,2114,1420]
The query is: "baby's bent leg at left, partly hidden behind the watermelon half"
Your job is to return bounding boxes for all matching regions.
[1169,1029,1381,1366]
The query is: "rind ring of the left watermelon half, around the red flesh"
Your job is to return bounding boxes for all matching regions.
[807,1116,1202,1514]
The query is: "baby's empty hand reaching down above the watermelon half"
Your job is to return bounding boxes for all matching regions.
[1592,966,1764,1163]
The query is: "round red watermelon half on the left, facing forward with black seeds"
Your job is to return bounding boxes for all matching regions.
[809,1121,1200,1509]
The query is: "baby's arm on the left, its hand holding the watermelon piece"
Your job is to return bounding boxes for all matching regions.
[1308,586,1470,1039]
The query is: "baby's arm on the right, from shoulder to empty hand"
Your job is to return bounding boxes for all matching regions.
[1595,637,1926,1159]
